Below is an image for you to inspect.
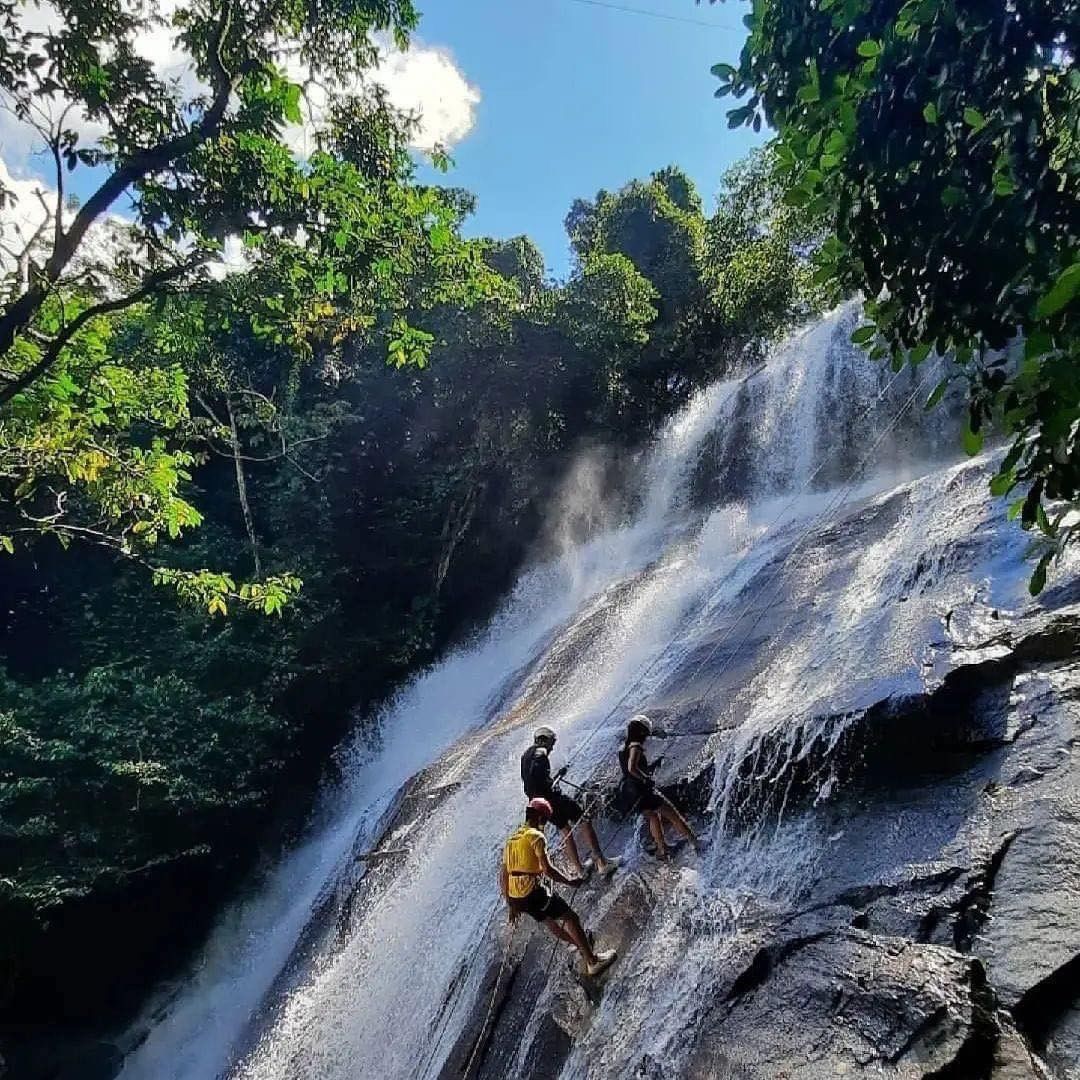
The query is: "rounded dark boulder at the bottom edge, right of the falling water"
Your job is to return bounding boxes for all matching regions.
[687,930,990,1080]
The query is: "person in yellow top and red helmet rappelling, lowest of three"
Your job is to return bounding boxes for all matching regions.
[499,798,617,975]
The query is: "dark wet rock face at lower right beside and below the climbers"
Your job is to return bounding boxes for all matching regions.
[443,609,1080,1080]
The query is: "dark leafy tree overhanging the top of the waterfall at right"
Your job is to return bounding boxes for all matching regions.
[714,0,1080,589]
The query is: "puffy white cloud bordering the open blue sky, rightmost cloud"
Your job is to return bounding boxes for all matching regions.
[373,39,481,150]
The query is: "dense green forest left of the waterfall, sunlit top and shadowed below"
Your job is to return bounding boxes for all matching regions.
[0,0,827,1018]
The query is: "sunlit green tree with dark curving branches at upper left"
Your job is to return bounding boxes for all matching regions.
[0,0,500,611]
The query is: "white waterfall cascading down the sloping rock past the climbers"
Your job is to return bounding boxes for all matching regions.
[116,307,1024,1080]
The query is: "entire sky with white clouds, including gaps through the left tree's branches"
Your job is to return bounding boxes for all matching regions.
[0,0,761,276]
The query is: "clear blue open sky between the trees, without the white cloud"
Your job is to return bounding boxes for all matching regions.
[418,0,761,275]
